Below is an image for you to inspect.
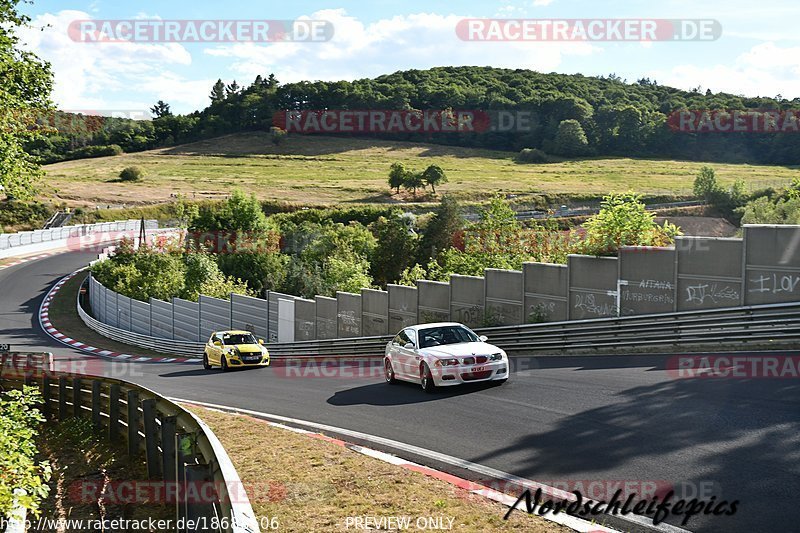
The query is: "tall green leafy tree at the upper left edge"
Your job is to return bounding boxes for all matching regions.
[0,0,53,198]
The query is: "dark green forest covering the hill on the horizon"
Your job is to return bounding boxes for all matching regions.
[26,67,800,164]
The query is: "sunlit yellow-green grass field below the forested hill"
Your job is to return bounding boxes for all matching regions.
[41,133,800,205]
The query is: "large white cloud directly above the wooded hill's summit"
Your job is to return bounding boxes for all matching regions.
[204,9,597,82]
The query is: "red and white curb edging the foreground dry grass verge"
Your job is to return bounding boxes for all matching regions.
[169,398,644,533]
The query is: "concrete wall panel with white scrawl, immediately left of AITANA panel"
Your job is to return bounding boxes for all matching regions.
[567,255,617,320]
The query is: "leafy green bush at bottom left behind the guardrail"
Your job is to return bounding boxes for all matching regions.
[0,387,50,517]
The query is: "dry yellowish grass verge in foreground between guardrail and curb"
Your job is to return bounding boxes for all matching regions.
[184,404,571,532]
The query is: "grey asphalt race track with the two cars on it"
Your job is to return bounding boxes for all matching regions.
[0,252,800,532]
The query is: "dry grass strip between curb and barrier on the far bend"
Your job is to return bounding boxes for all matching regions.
[48,272,173,357]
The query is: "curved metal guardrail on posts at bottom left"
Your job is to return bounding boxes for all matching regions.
[0,354,260,533]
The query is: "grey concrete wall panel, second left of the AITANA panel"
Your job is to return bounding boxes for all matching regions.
[522,263,569,322]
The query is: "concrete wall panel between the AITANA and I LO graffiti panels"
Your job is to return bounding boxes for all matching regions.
[675,237,742,311]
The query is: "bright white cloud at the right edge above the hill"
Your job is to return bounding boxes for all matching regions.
[649,42,800,99]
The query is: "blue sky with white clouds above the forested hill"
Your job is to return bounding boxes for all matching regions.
[19,0,800,118]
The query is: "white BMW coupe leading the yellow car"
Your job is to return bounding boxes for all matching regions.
[383,322,509,392]
